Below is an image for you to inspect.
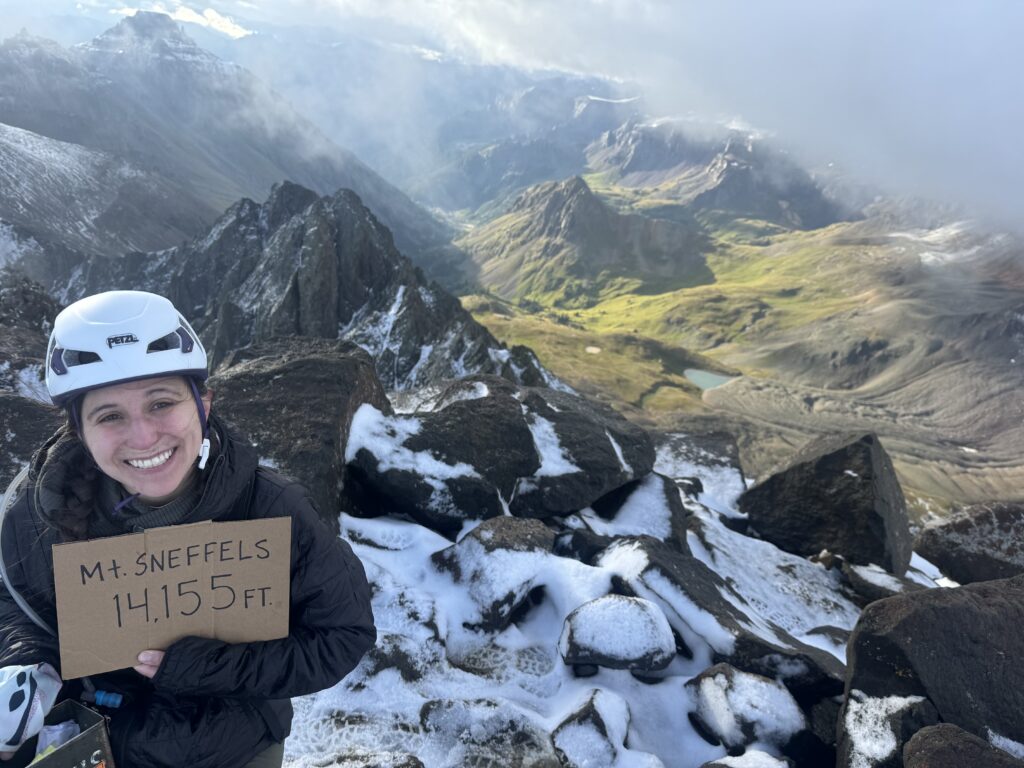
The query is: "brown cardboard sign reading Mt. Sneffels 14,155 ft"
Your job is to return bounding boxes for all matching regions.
[53,517,292,680]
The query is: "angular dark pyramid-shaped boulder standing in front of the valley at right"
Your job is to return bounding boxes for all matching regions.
[739,434,911,575]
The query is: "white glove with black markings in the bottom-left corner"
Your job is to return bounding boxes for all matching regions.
[0,664,63,754]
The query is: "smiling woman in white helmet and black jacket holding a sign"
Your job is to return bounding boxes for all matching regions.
[0,291,376,768]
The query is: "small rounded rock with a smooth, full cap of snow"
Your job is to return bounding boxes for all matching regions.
[558,595,676,672]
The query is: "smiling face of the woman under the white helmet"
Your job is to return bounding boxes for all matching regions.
[81,376,211,506]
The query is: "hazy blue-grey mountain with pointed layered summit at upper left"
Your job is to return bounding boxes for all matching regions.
[0,12,446,256]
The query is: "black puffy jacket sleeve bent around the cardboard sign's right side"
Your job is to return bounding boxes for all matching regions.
[153,484,377,698]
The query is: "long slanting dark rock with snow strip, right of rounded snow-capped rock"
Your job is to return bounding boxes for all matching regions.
[597,537,845,701]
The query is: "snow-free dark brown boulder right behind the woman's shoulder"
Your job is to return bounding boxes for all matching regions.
[210,337,390,531]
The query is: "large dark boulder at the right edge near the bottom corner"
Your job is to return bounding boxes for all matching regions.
[840,577,1024,761]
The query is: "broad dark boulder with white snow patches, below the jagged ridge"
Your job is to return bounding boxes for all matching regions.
[346,376,654,535]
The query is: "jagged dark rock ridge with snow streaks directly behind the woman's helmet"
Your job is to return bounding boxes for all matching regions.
[68,182,552,389]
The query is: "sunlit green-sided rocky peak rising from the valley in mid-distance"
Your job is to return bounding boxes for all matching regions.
[457,177,710,306]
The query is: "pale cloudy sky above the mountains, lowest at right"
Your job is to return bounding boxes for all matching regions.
[0,0,1024,223]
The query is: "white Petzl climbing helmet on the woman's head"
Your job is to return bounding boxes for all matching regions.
[46,291,207,406]
